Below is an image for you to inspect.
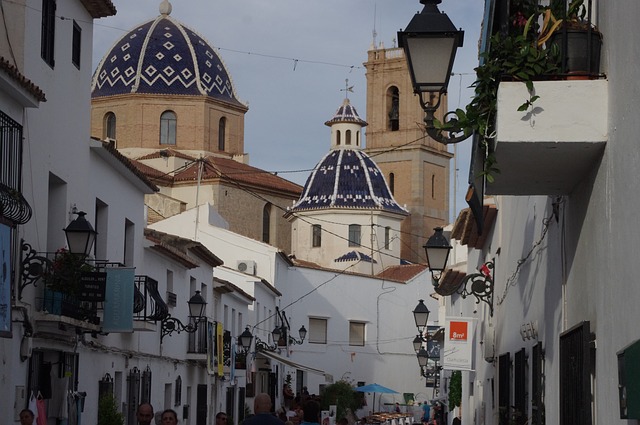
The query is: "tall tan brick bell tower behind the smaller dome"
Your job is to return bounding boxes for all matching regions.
[364,46,453,263]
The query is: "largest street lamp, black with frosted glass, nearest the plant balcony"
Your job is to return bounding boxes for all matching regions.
[398,0,469,145]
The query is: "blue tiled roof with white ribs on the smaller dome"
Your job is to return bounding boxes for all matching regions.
[290,149,409,215]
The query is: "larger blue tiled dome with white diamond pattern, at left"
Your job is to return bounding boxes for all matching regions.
[91,1,241,104]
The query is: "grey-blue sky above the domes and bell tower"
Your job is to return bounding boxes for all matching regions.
[93,0,484,220]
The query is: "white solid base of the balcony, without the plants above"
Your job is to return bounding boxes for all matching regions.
[486,79,609,195]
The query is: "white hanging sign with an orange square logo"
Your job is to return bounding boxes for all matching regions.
[442,317,476,370]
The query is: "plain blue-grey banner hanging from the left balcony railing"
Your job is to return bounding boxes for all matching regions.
[102,267,135,333]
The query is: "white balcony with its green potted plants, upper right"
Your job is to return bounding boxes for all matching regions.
[478,0,608,195]
